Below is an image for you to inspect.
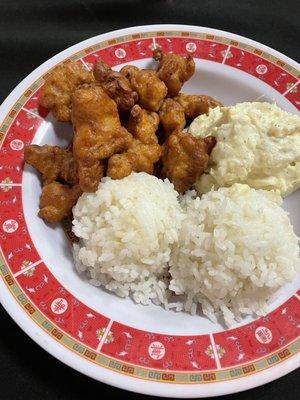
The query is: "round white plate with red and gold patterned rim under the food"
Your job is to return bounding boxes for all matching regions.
[0,25,300,398]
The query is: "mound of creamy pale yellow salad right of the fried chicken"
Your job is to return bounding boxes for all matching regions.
[189,102,300,196]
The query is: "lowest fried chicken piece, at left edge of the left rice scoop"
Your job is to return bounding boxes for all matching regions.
[38,182,82,222]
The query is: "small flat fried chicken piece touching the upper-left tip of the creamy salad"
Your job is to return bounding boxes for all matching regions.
[174,93,222,119]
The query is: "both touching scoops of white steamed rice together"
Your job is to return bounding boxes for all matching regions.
[73,173,300,325]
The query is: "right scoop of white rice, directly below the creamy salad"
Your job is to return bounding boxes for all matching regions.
[170,184,300,325]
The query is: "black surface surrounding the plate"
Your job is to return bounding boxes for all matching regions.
[0,0,300,400]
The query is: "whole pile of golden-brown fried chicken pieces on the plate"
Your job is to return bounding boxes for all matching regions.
[30,49,221,228]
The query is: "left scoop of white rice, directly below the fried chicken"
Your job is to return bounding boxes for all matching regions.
[73,173,183,304]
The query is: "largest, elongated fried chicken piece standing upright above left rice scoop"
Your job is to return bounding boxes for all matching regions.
[72,84,132,192]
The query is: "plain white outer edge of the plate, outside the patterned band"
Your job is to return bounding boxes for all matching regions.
[0,24,300,397]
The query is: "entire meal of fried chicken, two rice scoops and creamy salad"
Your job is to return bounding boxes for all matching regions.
[24,49,300,326]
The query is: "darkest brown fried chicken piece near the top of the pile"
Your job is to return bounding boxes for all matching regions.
[94,61,138,111]
